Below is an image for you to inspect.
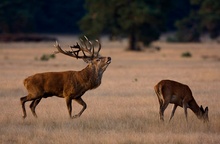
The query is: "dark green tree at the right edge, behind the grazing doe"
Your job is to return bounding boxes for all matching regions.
[176,0,220,42]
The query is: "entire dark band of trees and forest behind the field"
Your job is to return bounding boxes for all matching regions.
[0,0,220,50]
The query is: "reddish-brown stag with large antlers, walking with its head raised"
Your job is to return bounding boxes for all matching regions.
[20,37,111,118]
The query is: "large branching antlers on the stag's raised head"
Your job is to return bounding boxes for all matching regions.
[54,36,101,59]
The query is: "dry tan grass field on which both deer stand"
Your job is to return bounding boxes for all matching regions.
[0,36,220,144]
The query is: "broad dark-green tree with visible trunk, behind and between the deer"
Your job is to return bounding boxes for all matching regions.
[79,0,170,50]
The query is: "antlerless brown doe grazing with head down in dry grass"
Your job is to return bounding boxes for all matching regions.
[154,80,209,122]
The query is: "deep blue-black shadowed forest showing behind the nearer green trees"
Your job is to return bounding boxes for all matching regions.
[0,0,190,33]
